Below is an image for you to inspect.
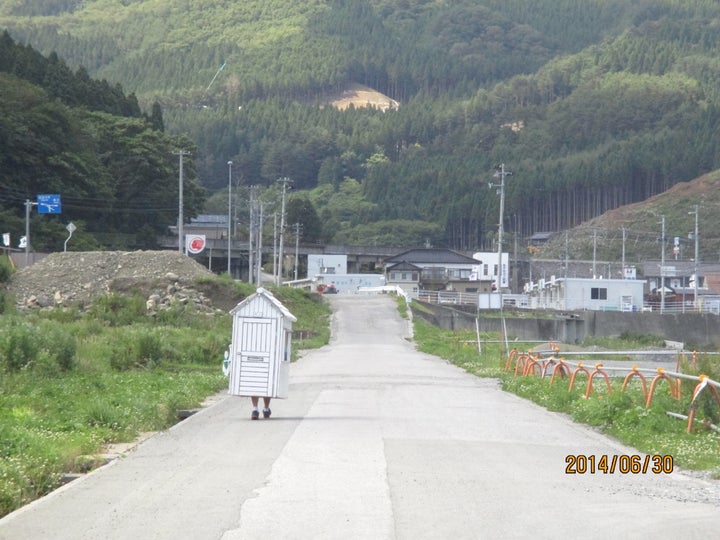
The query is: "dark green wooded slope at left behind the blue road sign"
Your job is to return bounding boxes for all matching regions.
[0,33,205,251]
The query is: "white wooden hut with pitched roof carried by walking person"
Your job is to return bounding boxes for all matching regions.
[223,287,297,420]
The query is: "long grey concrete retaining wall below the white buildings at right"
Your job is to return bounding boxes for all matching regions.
[411,303,720,350]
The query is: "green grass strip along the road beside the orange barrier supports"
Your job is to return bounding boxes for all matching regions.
[402,306,720,478]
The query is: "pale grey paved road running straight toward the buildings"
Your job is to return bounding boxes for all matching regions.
[0,295,720,540]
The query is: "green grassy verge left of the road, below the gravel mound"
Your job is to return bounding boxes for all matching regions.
[0,278,330,517]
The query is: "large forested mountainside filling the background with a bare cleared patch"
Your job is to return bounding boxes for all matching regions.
[0,0,720,254]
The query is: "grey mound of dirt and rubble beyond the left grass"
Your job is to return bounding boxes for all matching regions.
[8,251,212,307]
